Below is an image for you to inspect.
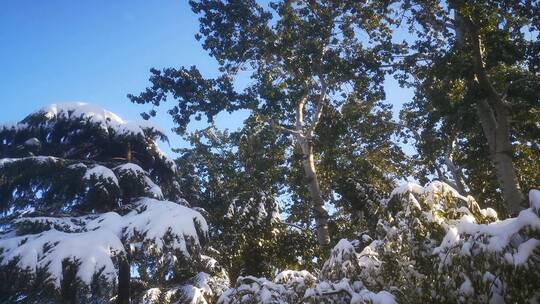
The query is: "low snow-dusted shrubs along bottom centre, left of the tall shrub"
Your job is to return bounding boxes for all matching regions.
[218,245,395,304]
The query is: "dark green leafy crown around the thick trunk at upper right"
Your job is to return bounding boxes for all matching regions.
[401,1,540,212]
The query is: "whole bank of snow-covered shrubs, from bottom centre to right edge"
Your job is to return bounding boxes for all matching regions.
[219,182,540,304]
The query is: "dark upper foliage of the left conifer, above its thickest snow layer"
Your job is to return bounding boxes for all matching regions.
[0,107,179,215]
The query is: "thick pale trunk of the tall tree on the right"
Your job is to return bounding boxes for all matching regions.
[460,13,524,213]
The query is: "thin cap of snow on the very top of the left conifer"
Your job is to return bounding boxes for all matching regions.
[32,102,165,135]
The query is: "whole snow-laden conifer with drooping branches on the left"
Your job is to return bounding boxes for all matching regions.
[0,103,227,303]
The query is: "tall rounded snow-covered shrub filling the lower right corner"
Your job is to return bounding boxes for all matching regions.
[352,182,540,303]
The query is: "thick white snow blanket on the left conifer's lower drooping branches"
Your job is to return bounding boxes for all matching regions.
[0,198,208,287]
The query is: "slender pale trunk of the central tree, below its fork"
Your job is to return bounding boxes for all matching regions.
[298,138,330,251]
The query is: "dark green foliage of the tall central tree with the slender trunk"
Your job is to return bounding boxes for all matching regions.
[129,1,407,278]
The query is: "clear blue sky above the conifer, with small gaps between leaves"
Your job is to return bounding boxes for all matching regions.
[0,0,411,157]
